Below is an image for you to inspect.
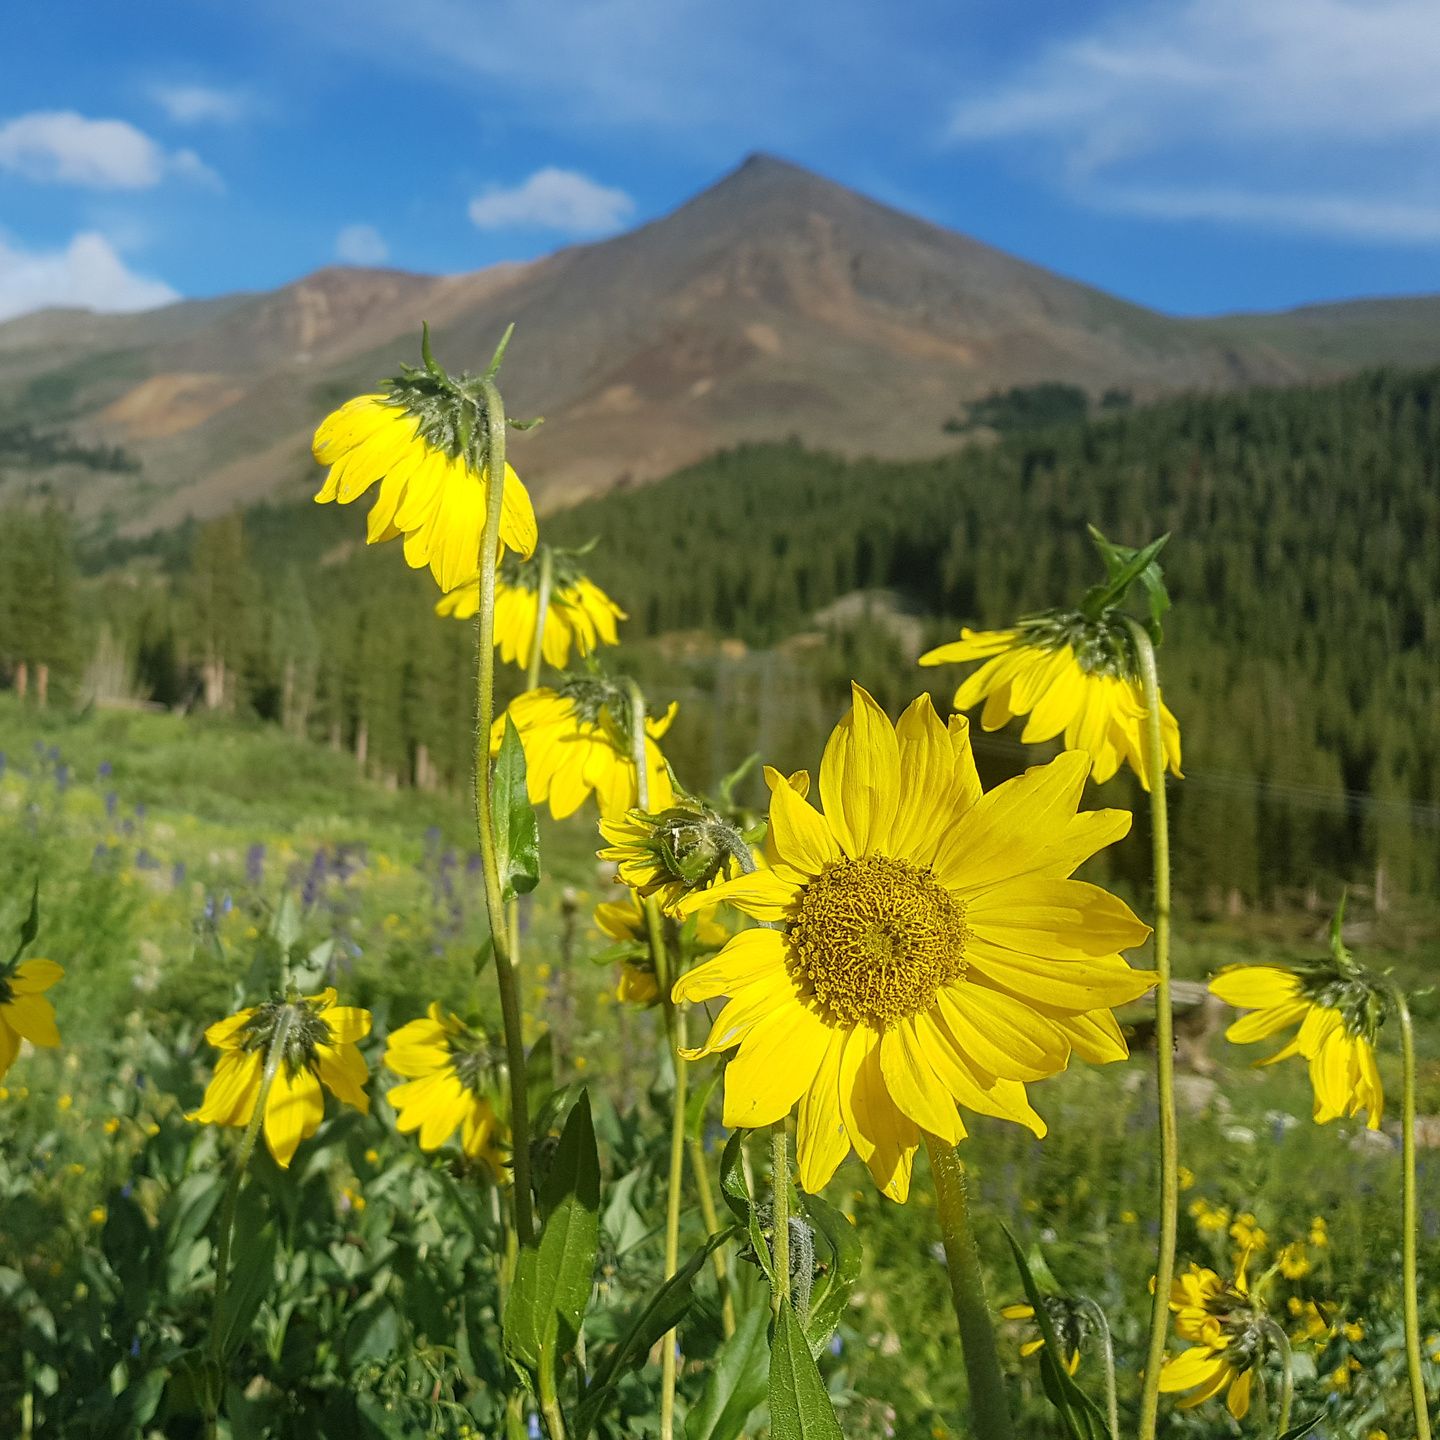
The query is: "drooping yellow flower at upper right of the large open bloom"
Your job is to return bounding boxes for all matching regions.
[920,626,1181,789]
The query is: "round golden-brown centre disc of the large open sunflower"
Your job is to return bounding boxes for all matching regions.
[791,855,969,1027]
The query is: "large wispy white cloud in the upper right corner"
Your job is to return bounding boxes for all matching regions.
[950,0,1440,242]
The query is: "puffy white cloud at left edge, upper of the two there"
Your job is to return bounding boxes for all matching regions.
[0,109,220,190]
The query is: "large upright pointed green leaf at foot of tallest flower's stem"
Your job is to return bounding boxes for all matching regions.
[504,1090,600,1374]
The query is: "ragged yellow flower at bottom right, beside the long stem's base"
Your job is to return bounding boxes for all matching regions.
[1159,1253,1264,1420]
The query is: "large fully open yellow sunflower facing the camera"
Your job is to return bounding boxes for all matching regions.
[674,685,1155,1201]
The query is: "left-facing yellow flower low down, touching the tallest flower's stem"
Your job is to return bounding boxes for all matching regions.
[384,1001,508,1178]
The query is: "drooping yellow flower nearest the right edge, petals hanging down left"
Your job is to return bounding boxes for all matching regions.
[1210,965,1385,1130]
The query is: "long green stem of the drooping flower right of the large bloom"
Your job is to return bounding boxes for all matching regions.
[1125,615,1179,1440]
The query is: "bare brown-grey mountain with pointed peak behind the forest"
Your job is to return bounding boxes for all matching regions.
[8,156,1440,534]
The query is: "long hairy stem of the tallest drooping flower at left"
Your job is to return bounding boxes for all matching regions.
[475,377,534,1244]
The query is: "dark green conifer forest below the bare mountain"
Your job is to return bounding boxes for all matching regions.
[0,372,1440,907]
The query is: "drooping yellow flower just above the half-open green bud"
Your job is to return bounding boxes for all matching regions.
[490,677,678,821]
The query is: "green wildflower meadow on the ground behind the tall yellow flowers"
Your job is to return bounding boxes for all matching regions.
[0,694,1440,1440]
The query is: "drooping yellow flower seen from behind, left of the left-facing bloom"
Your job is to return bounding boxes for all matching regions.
[186,989,370,1169]
